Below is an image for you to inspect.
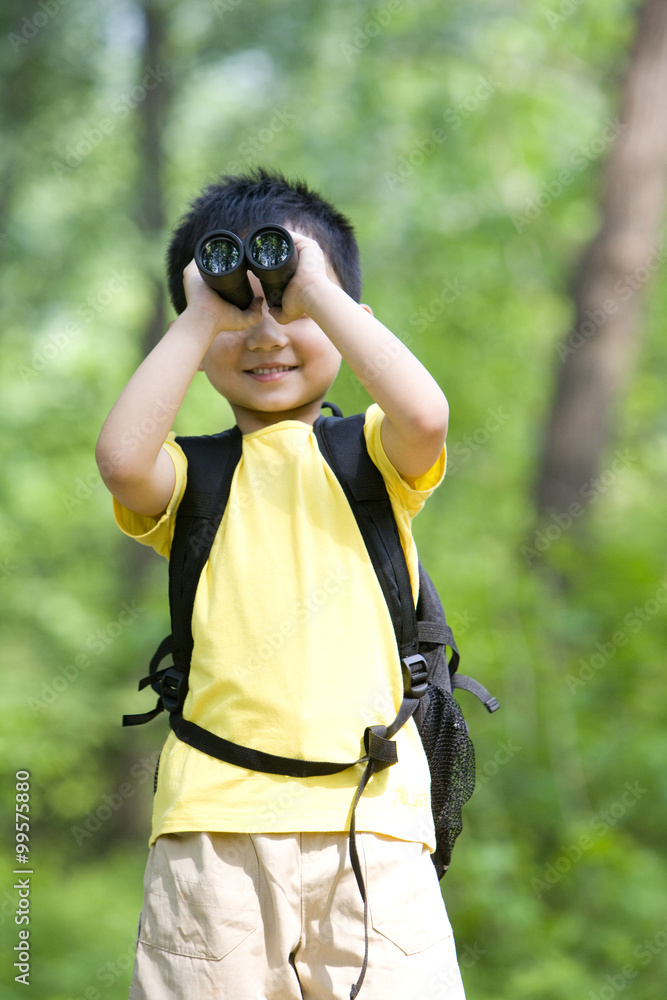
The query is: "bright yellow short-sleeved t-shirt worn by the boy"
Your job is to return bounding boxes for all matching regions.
[114,404,445,850]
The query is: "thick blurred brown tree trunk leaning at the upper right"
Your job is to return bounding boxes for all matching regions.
[536,0,667,514]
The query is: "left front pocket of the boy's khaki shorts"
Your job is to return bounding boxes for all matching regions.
[139,833,260,961]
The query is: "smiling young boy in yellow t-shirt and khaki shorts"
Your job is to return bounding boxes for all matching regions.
[97,171,464,1000]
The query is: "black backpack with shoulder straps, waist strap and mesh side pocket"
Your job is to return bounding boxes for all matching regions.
[123,403,499,996]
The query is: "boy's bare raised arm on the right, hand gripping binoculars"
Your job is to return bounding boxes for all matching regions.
[271,233,449,479]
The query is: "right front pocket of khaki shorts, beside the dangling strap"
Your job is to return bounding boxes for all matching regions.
[358,833,452,955]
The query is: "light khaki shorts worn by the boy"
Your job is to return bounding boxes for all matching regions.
[130,833,465,1000]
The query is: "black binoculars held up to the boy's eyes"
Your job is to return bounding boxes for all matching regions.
[195,225,298,309]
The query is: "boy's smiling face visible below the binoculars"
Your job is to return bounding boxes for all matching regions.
[201,272,341,434]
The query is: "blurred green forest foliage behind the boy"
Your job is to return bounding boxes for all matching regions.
[0,0,667,1000]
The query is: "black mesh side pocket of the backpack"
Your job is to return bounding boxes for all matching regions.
[419,685,475,878]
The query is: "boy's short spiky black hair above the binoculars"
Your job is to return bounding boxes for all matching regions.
[167,167,361,313]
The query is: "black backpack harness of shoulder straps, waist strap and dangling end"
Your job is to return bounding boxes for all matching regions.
[123,404,426,1000]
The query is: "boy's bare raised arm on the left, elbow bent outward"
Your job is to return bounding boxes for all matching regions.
[95,263,261,516]
